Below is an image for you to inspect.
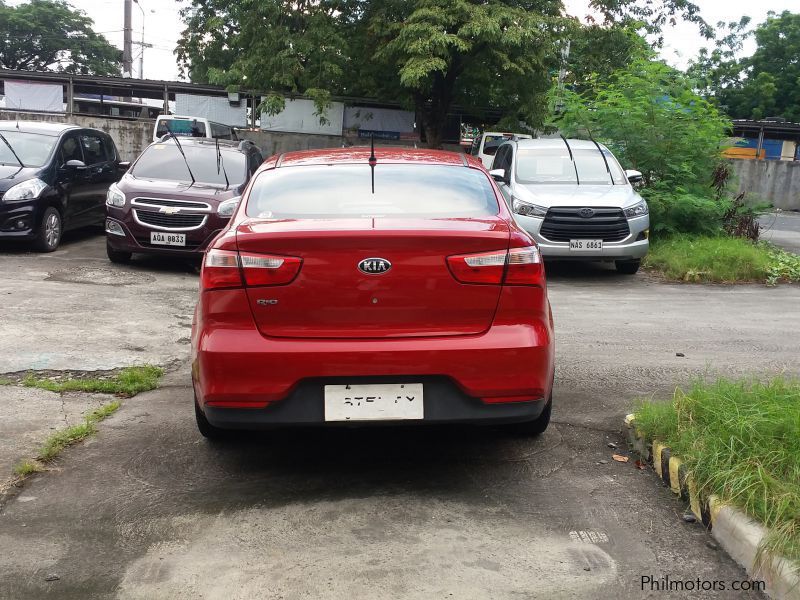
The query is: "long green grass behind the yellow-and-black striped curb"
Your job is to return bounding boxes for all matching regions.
[635,378,800,564]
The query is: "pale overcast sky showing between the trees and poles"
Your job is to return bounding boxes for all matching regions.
[8,0,800,80]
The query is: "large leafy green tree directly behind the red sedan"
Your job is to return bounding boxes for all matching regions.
[178,0,728,146]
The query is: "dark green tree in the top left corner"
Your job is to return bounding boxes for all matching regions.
[0,0,122,75]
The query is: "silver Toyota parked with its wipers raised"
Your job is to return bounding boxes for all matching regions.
[491,138,650,275]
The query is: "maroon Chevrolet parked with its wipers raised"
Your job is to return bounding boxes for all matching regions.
[106,136,263,263]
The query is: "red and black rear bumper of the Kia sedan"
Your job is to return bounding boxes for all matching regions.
[192,290,554,428]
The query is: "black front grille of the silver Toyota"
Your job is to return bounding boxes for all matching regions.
[539,206,630,242]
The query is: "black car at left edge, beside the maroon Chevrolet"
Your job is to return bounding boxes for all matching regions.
[0,121,130,252]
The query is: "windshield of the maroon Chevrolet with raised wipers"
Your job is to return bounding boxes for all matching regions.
[131,139,247,187]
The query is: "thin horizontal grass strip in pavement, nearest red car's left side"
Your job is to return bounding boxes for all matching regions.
[21,365,164,397]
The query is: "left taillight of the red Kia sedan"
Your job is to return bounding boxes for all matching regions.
[200,249,303,290]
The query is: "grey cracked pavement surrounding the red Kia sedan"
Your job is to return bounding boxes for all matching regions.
[0,236,800,599]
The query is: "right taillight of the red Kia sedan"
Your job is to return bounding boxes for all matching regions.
[447,246,544,285]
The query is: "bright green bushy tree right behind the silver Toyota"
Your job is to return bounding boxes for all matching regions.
[555,59,730,190]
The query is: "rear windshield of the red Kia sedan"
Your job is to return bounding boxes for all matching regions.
[247,164,499,219]
